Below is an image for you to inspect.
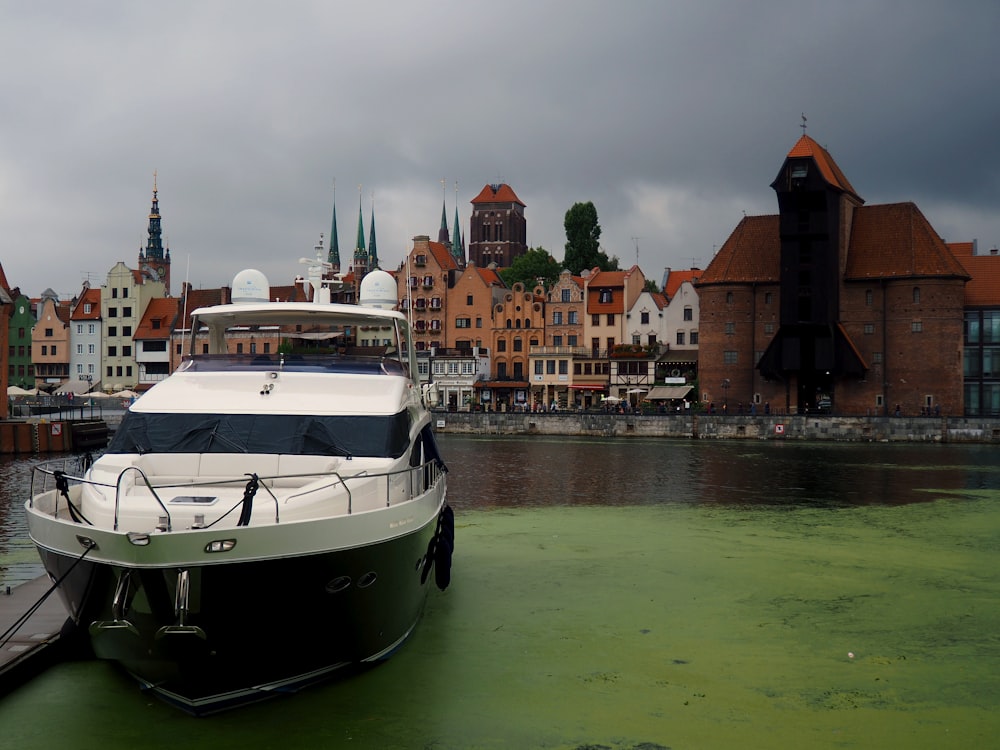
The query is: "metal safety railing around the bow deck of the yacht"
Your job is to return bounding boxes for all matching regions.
[29,460,443,532]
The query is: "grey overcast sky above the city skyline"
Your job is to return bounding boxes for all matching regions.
[0,0,1000,296]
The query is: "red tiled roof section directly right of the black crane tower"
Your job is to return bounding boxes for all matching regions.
[844,203,968,279]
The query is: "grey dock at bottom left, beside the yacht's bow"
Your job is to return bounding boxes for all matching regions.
[0,576,73,695]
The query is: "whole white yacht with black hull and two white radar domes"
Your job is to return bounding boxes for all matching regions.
[26,267,454,714]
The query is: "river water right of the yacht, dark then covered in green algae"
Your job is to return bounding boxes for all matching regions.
[0,437,1000,750]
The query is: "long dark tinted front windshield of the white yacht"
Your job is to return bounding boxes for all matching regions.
[107,411,410,458]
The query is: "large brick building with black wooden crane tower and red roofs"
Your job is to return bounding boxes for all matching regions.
[697,135,969,414]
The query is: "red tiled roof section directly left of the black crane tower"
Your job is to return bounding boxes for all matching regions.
[698,214,781,284]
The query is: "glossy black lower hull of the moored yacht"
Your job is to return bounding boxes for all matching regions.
[32,504,443,714]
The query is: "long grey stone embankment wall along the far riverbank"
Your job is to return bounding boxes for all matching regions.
[434,412,1000,443]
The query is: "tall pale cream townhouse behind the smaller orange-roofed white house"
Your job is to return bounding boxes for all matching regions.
[101,261,166,391]
